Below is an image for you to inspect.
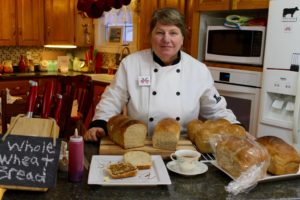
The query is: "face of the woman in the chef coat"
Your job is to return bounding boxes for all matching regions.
[151,22,183,65]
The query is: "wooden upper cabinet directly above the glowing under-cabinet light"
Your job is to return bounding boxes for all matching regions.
[45,0,94,47]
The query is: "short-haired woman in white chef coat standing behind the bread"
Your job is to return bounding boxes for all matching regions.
[84,8,238,141]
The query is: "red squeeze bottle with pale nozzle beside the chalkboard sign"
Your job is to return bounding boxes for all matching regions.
[68,129,84,182]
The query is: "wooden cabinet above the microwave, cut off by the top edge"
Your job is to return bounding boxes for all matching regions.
[197,0,269,11]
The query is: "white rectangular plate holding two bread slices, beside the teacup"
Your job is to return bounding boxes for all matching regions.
[88,155,171,186]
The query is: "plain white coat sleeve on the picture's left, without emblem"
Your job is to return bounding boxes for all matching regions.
[93,62,128,121]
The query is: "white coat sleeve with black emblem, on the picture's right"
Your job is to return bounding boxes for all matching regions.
[200,85,240,124]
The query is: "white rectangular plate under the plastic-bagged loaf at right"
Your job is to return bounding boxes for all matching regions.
[210,160,300,182]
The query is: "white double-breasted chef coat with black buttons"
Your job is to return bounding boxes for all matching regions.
[93,49,238,135]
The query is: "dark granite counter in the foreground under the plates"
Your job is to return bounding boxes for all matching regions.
[3,143,300,200]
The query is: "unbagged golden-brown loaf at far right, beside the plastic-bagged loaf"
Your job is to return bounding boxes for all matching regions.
[256,136,300,175]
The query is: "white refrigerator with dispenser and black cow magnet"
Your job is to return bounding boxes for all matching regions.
[257,0,300,152]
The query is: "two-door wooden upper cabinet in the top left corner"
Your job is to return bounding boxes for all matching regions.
[0,0,44,46]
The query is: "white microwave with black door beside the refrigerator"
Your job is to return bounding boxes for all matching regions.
[205,26,266,66]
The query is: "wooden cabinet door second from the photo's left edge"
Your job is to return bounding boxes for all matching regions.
[17,0,44,46]
